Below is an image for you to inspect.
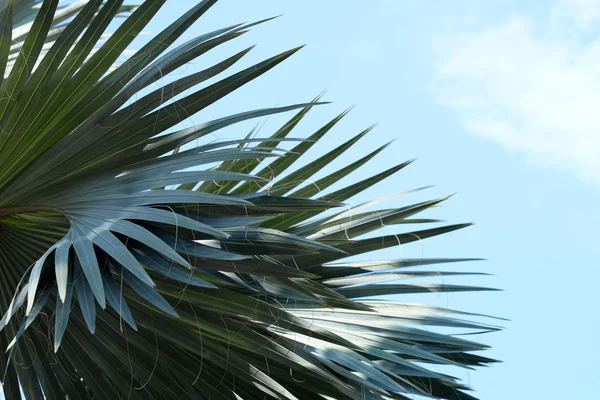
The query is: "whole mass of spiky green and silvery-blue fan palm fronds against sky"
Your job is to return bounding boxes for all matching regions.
[0,0,495,399]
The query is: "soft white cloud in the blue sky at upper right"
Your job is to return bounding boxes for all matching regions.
[433,9,600,184]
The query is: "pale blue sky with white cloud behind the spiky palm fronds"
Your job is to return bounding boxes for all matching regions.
[0,0,600,400]
